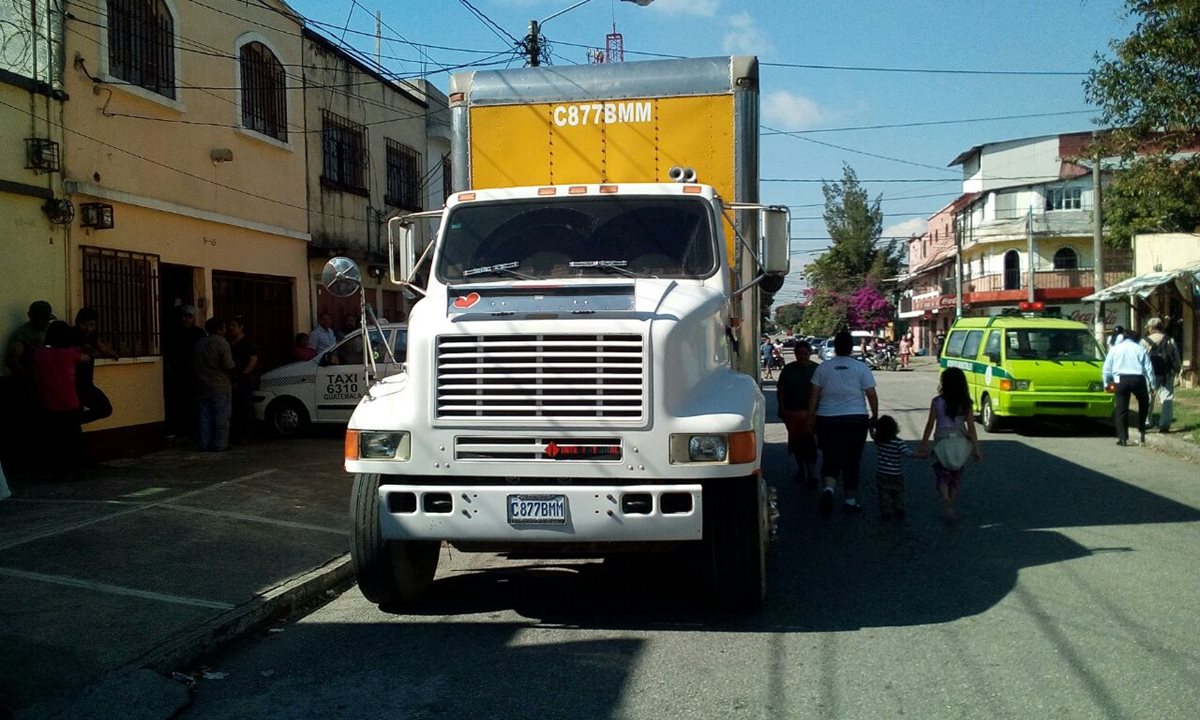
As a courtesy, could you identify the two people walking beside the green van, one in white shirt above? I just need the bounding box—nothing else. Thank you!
[1103,318,1182,446]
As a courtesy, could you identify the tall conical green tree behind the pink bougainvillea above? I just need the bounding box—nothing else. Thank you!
[803,166,901,335]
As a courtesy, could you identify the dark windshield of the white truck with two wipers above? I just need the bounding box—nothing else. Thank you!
[437,196,716,283]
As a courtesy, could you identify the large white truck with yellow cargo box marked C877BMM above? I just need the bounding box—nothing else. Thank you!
[346,58,790,607]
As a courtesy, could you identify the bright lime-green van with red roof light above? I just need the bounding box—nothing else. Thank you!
[941,314,1112,432]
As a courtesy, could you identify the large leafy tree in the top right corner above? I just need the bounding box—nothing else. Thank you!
[1084,0,1200,246]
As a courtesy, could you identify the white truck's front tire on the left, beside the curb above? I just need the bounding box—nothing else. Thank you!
[350,473,442,606]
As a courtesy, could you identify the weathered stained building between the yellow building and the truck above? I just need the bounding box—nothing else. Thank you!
[304,29,450,326]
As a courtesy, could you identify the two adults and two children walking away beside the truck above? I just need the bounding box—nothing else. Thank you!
[776,331,983,523]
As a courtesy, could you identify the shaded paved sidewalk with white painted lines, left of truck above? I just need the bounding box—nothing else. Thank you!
[0,433,353,719]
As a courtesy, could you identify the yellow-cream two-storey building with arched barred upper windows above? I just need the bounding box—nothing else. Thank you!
[60,0,312,455]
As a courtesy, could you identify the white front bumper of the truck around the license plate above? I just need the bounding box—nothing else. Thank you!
[379,484,703,542]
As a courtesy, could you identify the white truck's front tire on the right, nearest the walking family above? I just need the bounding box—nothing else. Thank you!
[704,475,767,610]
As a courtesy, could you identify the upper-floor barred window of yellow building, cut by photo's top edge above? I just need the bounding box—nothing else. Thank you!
[108,0,175,100]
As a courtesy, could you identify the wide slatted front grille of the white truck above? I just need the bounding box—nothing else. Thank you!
[437,335,646,420]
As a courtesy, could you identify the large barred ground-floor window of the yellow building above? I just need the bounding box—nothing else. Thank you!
[80,246,162,358]
